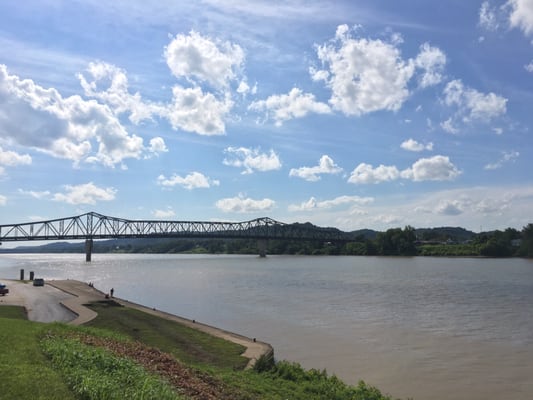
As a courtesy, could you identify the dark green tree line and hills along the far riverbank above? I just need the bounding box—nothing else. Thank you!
[94,224,533,257]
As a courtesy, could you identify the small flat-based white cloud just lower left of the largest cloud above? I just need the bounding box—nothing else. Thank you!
[249,88,331,126]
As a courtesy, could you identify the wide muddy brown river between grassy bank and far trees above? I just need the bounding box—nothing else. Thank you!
[0,254,533,400]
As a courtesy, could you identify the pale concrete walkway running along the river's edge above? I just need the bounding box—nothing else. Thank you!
[46,280,274,368]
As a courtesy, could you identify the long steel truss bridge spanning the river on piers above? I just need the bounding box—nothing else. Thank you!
[0,212,350,261]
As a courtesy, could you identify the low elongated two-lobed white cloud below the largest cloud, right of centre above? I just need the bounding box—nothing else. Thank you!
[348,155,461,184]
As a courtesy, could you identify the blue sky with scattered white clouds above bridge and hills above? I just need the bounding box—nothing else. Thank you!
[0,0,533,231]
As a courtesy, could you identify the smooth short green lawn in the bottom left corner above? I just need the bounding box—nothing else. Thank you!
[0,316,76,400]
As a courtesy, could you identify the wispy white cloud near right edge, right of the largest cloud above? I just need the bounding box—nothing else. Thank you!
[441,79,507,133]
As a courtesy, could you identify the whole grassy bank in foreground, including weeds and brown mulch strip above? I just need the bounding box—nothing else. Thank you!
[0,303,400,400]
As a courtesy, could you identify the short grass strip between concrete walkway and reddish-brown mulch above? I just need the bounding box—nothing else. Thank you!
[86,301,248,369]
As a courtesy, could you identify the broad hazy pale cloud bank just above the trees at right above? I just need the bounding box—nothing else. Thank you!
[306,185,533,231]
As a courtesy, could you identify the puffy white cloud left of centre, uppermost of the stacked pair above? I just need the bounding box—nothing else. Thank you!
[164,31,244,89]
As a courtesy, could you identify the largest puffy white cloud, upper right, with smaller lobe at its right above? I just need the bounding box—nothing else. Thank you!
[310,25,446,116]
